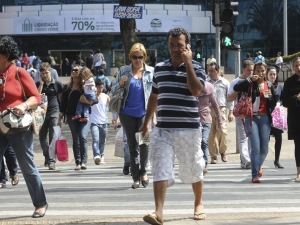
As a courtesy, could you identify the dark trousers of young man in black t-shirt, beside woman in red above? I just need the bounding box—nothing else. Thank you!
[39,113,58,164]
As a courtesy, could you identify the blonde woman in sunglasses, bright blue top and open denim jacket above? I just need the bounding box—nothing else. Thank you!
[111,43,154,189]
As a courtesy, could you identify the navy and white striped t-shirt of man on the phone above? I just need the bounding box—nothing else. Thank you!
[152,59,205,130]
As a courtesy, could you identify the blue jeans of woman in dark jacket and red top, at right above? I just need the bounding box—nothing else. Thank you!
[246,114,271,179]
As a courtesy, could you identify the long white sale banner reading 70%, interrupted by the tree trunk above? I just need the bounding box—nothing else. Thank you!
[14,15,192,34]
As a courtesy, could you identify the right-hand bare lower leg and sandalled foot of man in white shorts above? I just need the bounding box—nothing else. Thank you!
[192,180,206,220]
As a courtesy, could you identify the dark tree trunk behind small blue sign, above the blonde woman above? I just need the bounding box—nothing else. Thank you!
[120,0,138,65]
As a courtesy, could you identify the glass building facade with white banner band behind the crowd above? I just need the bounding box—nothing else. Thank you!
[0,0,300,74]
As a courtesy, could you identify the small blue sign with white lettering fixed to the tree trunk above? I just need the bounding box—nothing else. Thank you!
[113,5,143,19]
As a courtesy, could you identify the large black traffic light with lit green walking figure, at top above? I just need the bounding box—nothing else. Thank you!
[220,0,238,48]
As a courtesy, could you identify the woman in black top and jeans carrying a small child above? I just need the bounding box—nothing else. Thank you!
[57,64,98,171]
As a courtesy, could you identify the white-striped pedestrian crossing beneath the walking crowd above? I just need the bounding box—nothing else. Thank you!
[0,163,300,218]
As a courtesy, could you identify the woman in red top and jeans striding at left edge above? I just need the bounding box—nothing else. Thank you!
[0,36,48,218]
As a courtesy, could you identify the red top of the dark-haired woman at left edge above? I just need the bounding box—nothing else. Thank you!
[0,64,41,112]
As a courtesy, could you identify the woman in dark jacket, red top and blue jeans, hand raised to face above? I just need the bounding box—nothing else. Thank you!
[233,61,276,183]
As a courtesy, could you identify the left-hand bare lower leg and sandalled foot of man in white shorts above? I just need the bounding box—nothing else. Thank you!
[144,180,168,222]
